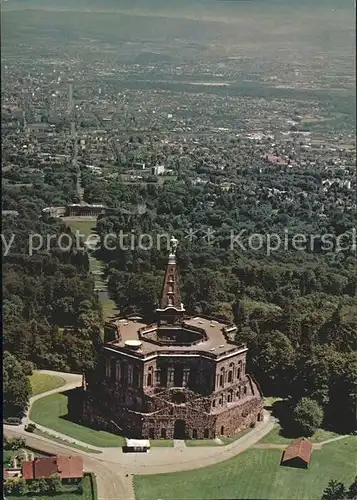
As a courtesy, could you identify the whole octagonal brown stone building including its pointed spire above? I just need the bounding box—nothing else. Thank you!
[75,238,263,439]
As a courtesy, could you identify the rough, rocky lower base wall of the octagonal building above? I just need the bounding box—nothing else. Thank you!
[83,380,263,439]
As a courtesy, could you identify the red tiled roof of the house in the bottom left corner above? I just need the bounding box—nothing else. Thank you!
[22,457,83,479]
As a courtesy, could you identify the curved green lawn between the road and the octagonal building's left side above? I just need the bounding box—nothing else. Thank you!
[30,394,124,447]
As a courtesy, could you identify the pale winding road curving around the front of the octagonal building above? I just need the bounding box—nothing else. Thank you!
[4,370,274,500]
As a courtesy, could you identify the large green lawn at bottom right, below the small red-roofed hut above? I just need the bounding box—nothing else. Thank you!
[134,436,357,500]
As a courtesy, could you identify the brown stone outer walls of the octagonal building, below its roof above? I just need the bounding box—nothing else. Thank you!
[80,332,263,439]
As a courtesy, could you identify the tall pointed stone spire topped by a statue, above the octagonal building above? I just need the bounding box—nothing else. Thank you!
[156,236,185,324]
